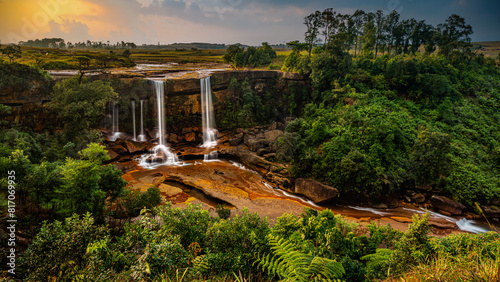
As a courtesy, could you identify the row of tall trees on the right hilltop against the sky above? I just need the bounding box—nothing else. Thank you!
[300,8,472,57]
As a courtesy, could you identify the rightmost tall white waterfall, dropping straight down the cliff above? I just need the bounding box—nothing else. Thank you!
[200,76,217,161]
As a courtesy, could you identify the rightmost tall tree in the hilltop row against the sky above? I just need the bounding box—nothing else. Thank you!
[438,14,472,56]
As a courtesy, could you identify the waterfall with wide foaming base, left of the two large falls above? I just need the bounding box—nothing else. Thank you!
[140,80,179,168]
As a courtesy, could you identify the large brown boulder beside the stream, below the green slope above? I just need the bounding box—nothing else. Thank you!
[295,178,339,203]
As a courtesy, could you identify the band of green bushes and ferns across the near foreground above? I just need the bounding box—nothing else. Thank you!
[16,204,500,281]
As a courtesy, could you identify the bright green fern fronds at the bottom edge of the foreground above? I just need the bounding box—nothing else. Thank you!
[256,235,345,281]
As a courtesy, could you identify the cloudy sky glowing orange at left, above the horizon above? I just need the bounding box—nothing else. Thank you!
[0,0,500,45]
